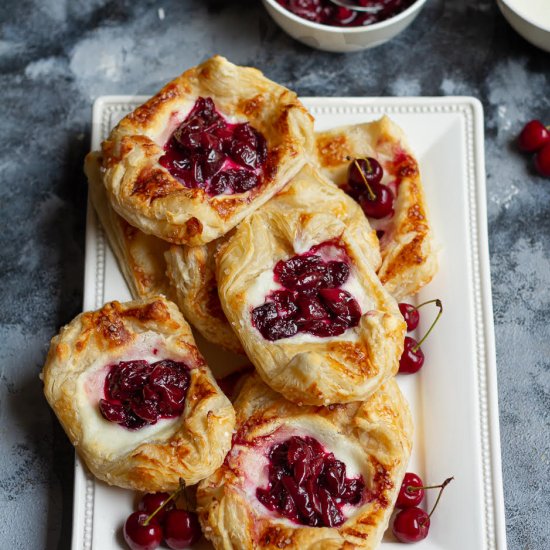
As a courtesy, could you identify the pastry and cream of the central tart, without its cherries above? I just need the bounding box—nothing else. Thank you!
[216,166,405,405]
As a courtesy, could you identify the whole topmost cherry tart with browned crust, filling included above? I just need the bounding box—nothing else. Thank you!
[102,56,314,245]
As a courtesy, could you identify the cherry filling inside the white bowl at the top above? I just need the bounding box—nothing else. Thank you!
[277,0,415,27]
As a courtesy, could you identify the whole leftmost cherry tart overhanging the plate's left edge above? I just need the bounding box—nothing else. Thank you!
[42,297,235,492]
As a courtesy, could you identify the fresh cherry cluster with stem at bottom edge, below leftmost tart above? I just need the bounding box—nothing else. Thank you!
[123,480,202,550]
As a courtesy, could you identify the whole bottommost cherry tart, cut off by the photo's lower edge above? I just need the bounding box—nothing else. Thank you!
[197,375,412,550]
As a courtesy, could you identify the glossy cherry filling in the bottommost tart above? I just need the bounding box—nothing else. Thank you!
[256,436,365,527]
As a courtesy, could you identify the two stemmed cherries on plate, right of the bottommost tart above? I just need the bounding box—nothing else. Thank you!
[392,472,453,543]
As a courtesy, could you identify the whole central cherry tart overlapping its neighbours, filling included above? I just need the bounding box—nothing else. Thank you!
[216,167,405,405]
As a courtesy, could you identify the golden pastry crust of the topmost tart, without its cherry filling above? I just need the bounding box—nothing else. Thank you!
[102,56,314,245]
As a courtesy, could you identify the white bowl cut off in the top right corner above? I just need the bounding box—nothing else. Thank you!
[497,0,550,52]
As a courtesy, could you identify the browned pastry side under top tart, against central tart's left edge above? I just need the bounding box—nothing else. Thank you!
[165,237,244,353]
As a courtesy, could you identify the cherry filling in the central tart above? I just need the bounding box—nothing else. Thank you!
[252,242,361,341]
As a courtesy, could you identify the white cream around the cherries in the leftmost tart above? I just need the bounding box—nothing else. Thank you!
[75,332,188,459]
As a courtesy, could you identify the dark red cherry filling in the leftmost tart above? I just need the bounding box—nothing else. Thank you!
[99,359,190,430]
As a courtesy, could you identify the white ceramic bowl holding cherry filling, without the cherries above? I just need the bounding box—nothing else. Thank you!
[262,0,432,52]
